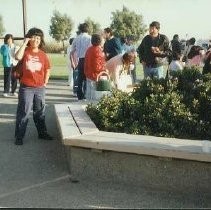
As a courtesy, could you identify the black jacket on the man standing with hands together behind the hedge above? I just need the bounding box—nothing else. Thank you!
[137,34,171,67]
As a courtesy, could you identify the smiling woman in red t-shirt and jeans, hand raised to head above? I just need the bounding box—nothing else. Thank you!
[15,28,53,145]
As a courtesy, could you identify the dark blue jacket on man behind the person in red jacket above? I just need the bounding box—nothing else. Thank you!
[104,37,122,60]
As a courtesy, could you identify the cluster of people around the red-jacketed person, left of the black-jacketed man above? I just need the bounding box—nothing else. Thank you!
[67,23,136,100]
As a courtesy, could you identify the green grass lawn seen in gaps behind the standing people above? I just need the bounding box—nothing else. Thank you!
[0,54,143,80]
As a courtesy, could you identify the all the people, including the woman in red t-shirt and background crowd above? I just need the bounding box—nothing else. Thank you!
[1,21,211,145]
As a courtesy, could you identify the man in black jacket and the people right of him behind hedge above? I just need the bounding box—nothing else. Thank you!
[138,21,211,78]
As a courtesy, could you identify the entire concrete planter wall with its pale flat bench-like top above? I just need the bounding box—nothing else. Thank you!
[55,103,211,192]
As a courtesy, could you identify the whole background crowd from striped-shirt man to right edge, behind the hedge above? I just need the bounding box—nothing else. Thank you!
[68,21,211,104]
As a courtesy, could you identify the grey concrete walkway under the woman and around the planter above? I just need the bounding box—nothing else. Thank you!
[0,80,211,209]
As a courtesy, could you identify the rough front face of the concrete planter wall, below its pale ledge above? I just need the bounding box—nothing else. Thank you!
[67,147,211,193]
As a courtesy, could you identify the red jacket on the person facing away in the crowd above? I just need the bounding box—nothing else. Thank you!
[84,46,105,81]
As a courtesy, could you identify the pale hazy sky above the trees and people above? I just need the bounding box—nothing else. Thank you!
[0,0,211,40]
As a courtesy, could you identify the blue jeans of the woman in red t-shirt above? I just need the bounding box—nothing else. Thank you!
[15,85,47,139]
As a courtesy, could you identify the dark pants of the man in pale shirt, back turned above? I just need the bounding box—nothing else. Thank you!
[77,58,86,100]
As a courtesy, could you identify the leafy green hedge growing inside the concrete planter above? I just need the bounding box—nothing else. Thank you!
[86,68,211,139]
